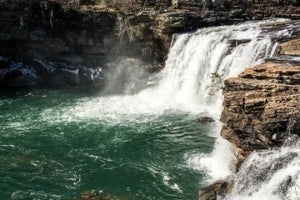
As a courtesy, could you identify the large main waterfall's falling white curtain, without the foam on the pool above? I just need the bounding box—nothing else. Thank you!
[142,23,273,114]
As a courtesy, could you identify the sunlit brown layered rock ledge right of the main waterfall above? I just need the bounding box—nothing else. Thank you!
[221,62,300,162]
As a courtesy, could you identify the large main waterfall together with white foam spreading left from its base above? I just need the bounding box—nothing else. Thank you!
[68,20,292,117]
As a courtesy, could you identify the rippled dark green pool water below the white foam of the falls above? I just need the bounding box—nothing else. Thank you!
[0,90,215,200]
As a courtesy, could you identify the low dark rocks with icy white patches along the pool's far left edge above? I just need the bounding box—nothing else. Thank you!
[0,57,103,88]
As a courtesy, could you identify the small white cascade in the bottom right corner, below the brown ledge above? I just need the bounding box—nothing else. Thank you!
[226,138,300,200]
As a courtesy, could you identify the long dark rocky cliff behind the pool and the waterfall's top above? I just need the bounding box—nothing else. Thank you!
[0,0,300,87]
